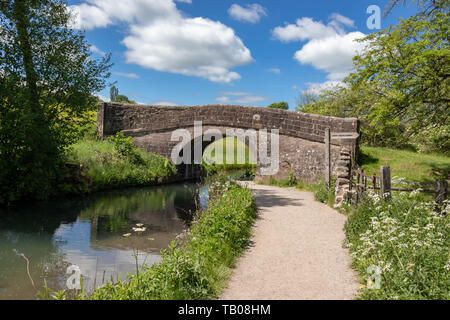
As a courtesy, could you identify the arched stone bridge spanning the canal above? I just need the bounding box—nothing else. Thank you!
[97,103,359,182]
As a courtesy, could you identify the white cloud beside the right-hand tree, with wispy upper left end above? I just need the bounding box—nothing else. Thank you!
[272,13,365,81]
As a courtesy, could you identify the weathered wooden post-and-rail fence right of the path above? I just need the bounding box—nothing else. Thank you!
[350,167,448,208]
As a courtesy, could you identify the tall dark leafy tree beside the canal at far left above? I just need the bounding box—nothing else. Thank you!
[0,0,111,203]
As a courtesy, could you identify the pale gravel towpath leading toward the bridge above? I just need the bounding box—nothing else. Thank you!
[221,183,359,300]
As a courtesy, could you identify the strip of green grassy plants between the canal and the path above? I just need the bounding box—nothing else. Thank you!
[89,181,257,300]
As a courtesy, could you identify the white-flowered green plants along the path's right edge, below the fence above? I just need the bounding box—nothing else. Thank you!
[345,192,450,300]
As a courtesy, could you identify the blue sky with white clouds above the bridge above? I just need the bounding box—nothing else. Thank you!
[68,0,415,110]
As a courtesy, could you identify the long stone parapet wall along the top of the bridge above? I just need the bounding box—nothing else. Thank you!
[98,102,359,145]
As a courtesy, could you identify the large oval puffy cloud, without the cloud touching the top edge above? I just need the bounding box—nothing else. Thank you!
[123,18,253,83]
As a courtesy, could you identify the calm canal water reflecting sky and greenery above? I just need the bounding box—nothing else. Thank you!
[0,184,207,299]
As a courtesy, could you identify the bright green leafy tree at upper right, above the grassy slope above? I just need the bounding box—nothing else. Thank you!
[347,0,450,132]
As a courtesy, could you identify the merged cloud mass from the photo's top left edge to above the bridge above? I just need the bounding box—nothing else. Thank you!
[71,0,253,83]
